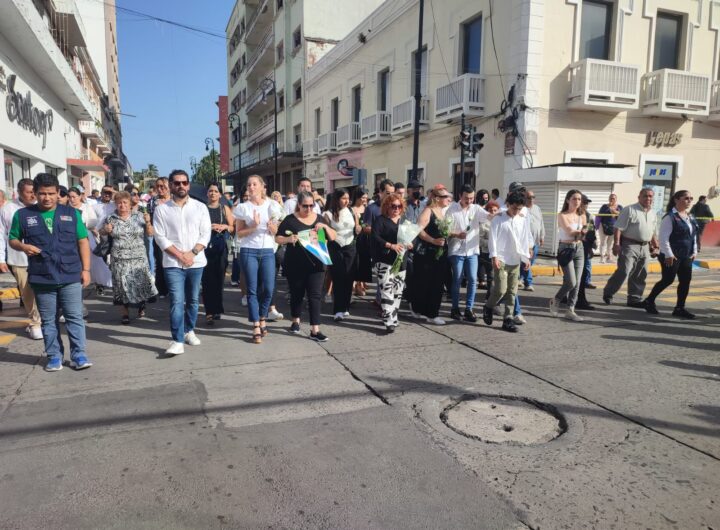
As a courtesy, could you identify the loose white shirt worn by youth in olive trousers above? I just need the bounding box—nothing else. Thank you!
[488,212,535,265]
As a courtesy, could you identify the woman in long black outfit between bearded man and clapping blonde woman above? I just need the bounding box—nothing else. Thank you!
[202,182,235,326]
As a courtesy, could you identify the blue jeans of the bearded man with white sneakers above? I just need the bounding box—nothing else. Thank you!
[164,267,203,342]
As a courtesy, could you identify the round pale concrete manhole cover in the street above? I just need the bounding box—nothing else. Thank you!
[440,394,567,445]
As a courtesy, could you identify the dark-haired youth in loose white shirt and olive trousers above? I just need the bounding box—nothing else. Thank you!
[483,191,534,332]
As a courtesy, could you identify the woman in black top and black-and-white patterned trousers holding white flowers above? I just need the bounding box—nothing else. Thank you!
[370,193,412,333]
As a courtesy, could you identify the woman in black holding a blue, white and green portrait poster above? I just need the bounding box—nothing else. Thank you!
[275,191,335,342]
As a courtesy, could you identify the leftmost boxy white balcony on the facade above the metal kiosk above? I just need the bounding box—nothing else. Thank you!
[567,59,640,111]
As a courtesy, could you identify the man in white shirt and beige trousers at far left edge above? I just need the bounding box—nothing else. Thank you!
[0,179,43,340]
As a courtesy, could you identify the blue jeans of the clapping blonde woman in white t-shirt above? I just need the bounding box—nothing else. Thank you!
[240,248,275,322]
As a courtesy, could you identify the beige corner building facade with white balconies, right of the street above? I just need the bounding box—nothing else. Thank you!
[303,0,720,233]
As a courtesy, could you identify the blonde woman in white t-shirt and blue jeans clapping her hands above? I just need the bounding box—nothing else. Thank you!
[233,175,282,344]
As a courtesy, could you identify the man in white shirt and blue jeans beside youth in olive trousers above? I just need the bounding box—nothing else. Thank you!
[445,184,488,322]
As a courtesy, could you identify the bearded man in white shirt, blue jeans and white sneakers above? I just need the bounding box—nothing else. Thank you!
[154,169,211,355]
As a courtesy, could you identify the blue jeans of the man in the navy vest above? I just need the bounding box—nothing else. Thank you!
[35,283,85,359]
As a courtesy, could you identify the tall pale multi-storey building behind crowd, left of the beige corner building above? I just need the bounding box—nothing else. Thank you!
[226,0,383,193]
